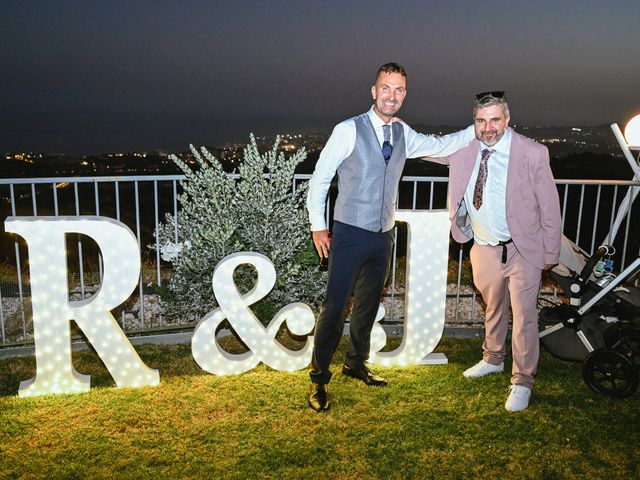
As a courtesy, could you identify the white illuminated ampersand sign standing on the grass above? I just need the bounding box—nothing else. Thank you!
[191,252,315,375]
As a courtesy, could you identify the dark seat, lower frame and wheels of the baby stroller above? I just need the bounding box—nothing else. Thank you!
[538,246,640,398]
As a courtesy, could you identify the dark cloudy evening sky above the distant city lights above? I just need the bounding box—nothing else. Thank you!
[0,0,640,153]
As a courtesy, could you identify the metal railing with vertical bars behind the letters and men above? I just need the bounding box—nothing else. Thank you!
[0,175,640,346]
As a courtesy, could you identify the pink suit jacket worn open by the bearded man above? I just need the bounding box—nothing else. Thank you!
[428,130,562,268]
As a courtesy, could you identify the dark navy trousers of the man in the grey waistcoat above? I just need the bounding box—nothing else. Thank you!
[310,221,393,383]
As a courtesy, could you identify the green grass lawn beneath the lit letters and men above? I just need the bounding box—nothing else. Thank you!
[0,339,640,479]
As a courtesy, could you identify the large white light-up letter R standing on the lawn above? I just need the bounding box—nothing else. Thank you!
[5,216,160,397]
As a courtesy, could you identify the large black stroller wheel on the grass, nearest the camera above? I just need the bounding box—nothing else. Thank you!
[582,350,638,398]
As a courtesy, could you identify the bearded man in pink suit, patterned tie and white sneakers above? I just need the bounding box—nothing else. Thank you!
[429,92,562,411]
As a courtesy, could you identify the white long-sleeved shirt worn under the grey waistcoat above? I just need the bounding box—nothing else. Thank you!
[307,107,475,231]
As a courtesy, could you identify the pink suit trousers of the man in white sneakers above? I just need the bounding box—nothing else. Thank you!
[471,242,542,389]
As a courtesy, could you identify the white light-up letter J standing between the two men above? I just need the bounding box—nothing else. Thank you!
[370,210,450,366]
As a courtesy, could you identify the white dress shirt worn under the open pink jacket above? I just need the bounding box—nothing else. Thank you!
[464,128,511,245]
